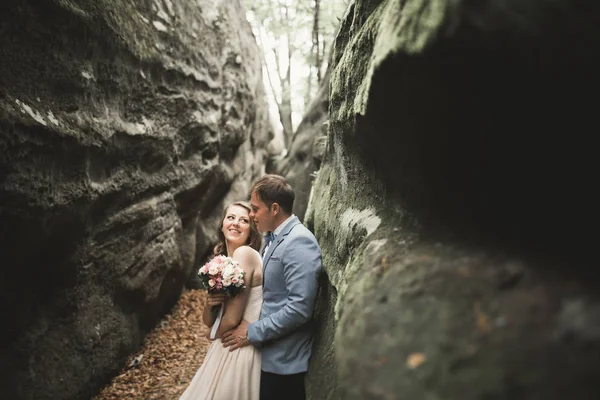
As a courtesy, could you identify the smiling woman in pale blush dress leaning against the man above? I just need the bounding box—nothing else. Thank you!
[179,202,262,400]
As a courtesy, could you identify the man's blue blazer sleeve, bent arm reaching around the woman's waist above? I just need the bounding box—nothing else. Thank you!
[248,236,322,345]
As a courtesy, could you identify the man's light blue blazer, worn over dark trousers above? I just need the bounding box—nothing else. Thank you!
[248,217,322,375]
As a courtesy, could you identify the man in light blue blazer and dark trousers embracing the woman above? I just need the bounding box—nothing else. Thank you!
[221,175,322,400]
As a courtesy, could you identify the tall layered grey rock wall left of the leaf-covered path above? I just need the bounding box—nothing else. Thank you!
[0,0,271,399]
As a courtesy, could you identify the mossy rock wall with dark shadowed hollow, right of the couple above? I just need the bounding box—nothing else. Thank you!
[308,0,600,400]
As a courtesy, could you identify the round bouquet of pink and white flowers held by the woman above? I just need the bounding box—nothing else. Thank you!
[198,255,246,297]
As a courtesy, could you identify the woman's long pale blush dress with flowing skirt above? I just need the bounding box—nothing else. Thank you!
[179,285,263,400]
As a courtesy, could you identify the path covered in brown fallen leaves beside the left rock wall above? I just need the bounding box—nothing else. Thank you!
[93,290,209,400]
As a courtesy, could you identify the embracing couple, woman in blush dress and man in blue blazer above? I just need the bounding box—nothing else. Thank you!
[180,175,322,400]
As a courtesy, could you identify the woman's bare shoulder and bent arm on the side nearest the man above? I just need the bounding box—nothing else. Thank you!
[216,246,260,338]
